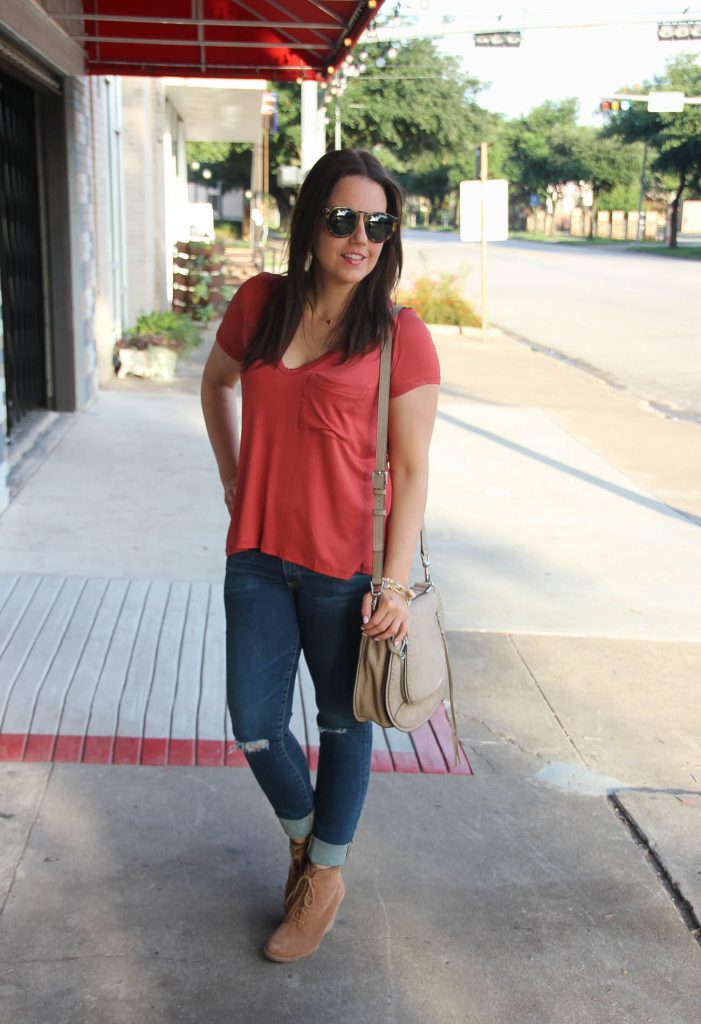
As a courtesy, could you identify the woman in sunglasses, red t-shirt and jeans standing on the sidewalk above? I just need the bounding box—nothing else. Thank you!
[202,151,440,963]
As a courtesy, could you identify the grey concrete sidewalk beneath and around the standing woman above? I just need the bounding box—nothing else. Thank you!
[0,323,701,1024]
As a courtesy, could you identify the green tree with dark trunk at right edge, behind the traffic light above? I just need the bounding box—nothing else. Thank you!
[605,53,701,247]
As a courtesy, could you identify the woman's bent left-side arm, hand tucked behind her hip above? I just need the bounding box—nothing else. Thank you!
[201,341,240,512]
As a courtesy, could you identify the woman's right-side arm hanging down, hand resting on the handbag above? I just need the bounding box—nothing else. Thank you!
[362,384,438,643]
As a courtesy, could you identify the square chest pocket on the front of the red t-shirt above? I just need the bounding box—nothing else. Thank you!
[300,374,375,452]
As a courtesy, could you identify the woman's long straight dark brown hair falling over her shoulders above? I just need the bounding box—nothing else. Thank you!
[243,150,402,370]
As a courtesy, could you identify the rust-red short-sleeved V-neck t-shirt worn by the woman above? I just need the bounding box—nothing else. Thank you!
[217,273,440,579]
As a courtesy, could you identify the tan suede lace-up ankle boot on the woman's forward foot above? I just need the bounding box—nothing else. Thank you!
[263,863,346,964]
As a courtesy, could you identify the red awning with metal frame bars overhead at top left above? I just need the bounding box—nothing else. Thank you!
[67,0,383,81]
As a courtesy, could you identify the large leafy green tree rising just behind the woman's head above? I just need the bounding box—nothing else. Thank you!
[330,39,488,221]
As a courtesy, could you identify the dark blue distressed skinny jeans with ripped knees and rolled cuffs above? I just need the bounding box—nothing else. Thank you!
[224,550,373,866]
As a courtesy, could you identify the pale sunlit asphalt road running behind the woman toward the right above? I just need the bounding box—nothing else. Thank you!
[403,230,701,425]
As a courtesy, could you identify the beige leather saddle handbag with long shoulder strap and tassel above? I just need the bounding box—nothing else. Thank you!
[353,315,461,765]
